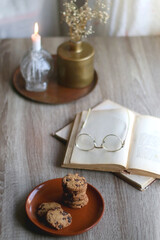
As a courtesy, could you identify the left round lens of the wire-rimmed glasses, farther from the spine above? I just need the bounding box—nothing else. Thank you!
[76,134,94,151]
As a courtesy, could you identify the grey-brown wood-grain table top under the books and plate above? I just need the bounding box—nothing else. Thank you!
[0,37,160,240]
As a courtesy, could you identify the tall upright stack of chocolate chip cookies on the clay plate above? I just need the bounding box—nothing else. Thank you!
[62,173,89,208]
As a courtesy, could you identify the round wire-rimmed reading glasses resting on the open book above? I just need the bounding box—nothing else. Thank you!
[75,109,129,152]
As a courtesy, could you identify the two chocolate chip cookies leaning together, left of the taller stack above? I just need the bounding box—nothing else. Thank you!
[37,202,72,230]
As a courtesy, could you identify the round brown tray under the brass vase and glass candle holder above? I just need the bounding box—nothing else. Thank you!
[13,55,98,104]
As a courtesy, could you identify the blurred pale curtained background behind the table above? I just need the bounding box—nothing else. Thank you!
[0,0,160,38]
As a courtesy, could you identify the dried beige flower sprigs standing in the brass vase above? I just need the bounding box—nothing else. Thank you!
[62,0,109,41]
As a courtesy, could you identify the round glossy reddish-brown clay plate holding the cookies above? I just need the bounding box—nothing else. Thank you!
[26,178,104,236]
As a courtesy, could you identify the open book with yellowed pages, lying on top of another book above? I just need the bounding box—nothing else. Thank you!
[63,101,160,178]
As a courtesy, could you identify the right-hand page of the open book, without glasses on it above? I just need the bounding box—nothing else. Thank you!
[128,116,160,174]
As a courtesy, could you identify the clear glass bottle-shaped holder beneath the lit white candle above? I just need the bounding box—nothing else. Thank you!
[20,48,53,92]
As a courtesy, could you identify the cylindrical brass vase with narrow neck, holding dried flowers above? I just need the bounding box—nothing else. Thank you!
[57,41,95,88]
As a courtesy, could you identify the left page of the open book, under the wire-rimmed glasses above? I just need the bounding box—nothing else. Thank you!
[70,108,135,167]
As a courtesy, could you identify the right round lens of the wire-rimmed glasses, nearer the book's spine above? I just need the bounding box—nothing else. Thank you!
[103,134,122,152]
